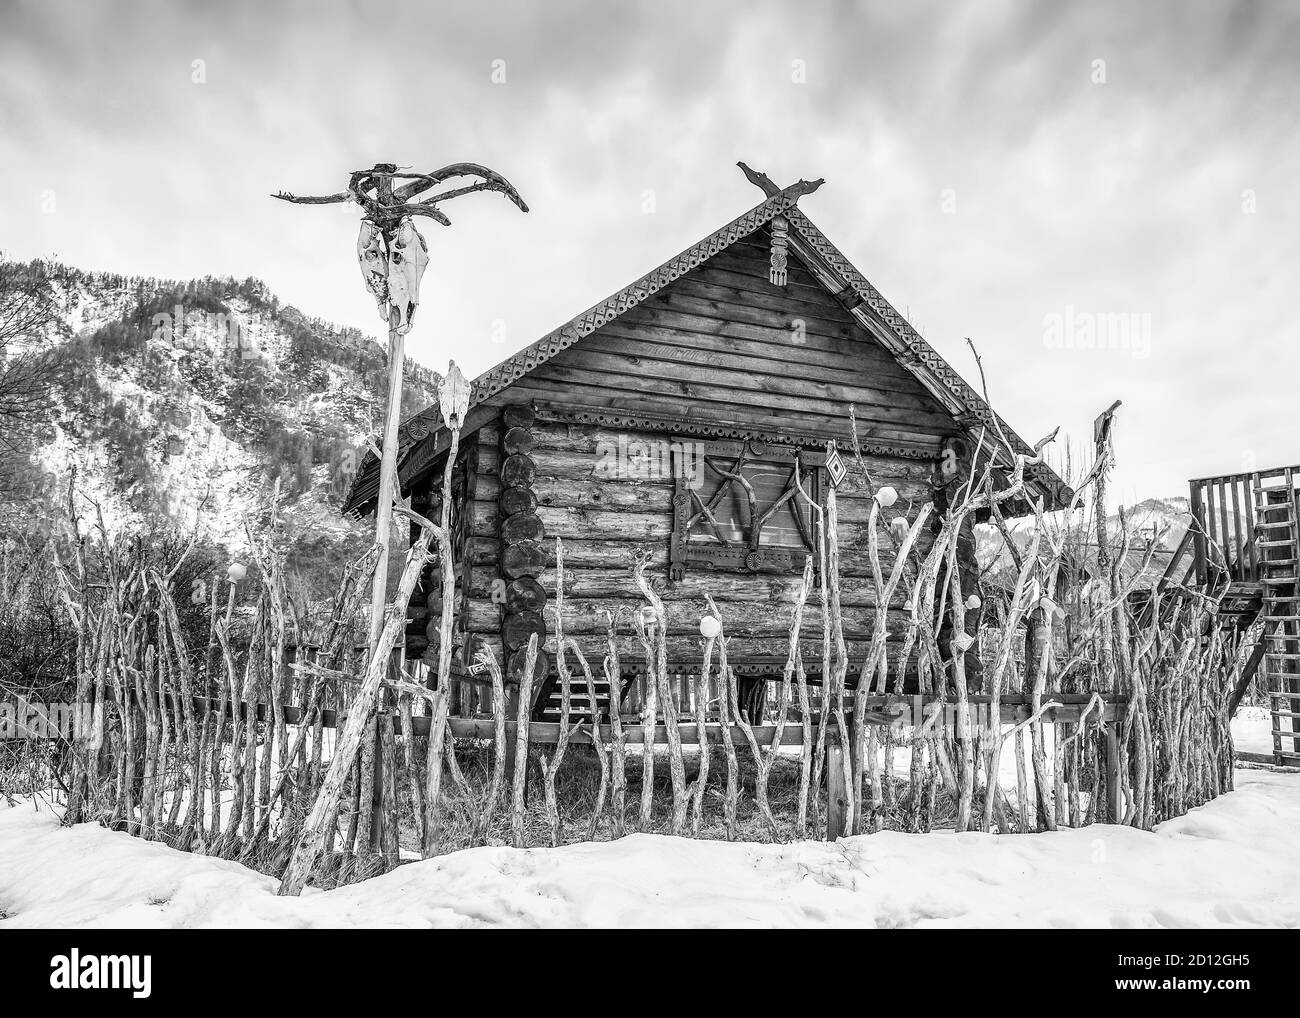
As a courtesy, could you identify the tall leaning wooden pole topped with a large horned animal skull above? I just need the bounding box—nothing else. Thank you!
[273,163,528,893]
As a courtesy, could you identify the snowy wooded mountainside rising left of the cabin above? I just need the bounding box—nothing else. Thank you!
[9,258,437,549]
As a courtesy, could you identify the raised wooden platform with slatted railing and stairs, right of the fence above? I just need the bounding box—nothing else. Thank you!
[1138,464,1300,767]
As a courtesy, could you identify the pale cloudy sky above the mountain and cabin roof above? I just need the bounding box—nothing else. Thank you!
[0,0,1300,502]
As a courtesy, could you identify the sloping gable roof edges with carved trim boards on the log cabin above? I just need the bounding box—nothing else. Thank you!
[343,181,1073,515]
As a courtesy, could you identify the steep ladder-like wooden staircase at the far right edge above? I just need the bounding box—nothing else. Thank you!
[1252,467,1300,767]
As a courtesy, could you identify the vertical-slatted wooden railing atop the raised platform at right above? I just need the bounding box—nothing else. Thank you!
[1188,465,1300,585]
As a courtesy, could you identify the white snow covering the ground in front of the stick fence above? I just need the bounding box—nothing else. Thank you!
[0,770,1300,928]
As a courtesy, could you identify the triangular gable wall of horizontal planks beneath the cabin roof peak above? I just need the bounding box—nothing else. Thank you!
[483,231,958,455]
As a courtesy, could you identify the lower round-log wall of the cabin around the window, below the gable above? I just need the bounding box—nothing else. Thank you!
[454,417,956,671]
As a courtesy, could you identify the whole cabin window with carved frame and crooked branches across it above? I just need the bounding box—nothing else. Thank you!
[670,439,826,580]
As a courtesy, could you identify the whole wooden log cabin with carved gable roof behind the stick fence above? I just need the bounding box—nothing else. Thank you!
[345,168,1071,716]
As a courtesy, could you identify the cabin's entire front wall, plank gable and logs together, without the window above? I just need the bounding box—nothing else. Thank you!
[410,230,974,681]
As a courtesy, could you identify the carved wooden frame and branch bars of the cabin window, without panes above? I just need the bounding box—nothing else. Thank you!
[668,438,828,580]
